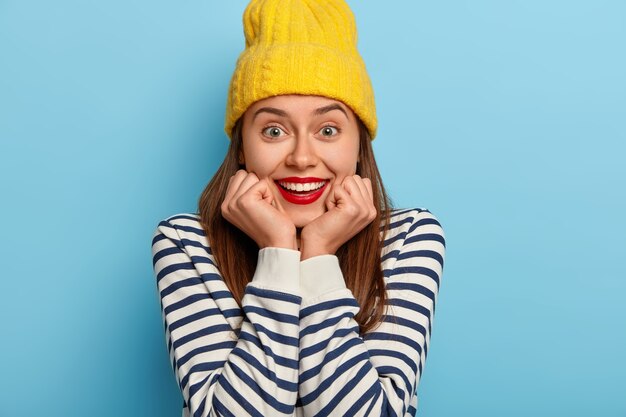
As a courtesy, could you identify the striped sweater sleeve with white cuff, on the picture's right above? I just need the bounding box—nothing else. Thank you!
[299,210,445,417]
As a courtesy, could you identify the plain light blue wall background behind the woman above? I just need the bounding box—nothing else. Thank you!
[0,0,626,417]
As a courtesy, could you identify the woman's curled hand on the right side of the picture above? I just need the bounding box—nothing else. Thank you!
[300,175,377,260]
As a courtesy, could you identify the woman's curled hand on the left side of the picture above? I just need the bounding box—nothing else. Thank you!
[221,170,297,249]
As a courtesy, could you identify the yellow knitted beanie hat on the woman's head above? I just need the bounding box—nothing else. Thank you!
[224,0,377,139]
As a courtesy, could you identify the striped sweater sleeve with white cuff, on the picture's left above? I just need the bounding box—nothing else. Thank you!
[152,221,301,416]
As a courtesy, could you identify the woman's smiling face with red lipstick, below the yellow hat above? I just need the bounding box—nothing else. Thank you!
[242,95,359,227]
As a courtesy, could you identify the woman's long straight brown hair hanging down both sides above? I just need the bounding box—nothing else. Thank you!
[198,118,391,334]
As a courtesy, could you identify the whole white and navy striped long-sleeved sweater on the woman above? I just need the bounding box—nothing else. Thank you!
[152,209,445,417]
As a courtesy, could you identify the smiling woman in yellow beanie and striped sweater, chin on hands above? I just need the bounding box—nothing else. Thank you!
[152,0,445,416]
